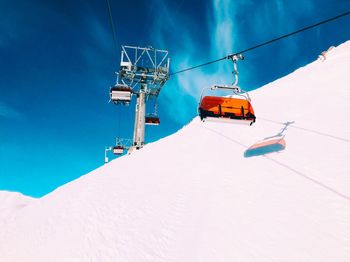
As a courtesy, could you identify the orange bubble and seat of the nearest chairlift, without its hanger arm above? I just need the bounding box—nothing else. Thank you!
[198,96,256,125]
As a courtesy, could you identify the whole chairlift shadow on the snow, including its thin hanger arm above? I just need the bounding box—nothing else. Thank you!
[244,121,294,157]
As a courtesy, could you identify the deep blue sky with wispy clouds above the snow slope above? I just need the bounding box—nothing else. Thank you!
[0,0,350,197]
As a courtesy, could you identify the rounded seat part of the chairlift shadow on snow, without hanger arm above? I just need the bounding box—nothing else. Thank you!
[244,137,286,157]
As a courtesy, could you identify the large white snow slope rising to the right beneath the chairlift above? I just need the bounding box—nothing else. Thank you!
[0,41,350,262]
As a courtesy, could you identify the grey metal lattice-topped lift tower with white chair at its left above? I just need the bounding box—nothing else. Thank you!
[110,46,170,149]
